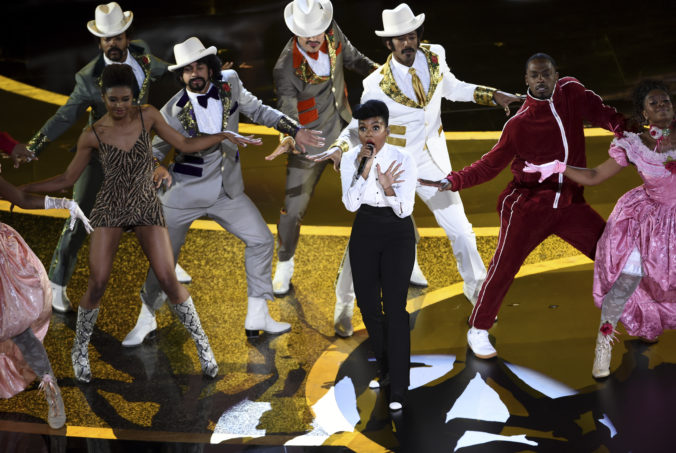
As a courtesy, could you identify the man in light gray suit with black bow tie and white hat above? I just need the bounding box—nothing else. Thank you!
[122,37,324,346]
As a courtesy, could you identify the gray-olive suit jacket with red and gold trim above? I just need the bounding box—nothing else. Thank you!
[273,22,378,154]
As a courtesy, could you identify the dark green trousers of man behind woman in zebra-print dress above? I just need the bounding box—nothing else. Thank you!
[49,156,103,286]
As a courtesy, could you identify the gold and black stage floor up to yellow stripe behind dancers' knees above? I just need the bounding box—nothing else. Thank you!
[0,212,676,452]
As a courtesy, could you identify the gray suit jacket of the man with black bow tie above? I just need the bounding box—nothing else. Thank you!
[153,70,291,208]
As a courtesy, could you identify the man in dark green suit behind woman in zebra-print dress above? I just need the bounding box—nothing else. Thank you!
[28,2,167,312]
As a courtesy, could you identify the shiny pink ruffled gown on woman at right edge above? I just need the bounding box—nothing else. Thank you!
[594,132,676,339]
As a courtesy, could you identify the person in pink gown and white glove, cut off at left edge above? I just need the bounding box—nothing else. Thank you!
[0,132,91,429]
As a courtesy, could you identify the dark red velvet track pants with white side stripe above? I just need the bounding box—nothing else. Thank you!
[469,189,605,329]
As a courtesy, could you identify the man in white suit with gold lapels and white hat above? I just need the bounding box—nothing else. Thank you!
[320,3,520,310]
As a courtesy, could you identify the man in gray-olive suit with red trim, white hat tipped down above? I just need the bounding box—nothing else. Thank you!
[273,0,378,296]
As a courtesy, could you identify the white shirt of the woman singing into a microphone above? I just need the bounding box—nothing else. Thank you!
[340,143,418,218]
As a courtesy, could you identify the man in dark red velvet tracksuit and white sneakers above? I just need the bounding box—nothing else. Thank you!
[421,53,625,359]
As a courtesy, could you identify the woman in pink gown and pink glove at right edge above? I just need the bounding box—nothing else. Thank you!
[527,80,676,378]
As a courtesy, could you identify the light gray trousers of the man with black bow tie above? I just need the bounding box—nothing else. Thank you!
[143,191,275,309]
